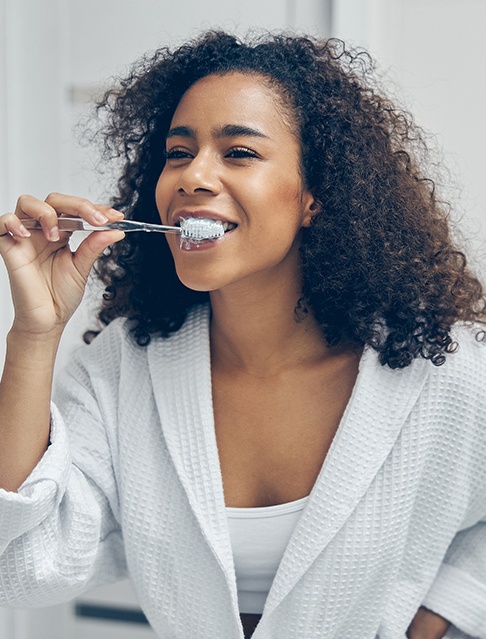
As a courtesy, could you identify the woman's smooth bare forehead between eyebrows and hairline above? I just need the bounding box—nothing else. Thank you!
[171,72,296,134]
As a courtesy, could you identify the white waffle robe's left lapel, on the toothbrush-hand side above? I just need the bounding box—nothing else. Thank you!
[148,306,237,606]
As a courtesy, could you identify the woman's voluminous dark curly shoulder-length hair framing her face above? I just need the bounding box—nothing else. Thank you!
[85,31,486,368]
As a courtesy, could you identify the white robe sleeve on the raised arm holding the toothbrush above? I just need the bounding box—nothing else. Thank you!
[0,328,126,607]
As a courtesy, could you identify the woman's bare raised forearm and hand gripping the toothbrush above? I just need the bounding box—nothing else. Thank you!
[0,194,123,491]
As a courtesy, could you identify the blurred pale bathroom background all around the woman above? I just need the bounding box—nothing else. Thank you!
[0,0,486,639]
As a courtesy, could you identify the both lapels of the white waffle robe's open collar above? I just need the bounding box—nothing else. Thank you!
[148,306,430,615]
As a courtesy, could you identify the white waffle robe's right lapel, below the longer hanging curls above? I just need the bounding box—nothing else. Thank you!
[265,349,430,614]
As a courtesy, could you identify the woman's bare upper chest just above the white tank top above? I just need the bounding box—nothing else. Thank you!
[213,359,357,507]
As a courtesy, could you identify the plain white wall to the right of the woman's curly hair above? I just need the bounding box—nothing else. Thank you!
[333,0,486,274]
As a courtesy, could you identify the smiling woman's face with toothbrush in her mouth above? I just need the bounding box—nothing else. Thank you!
[156,73,314,291]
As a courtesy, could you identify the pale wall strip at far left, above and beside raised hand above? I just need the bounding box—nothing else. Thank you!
[0,0,70,370]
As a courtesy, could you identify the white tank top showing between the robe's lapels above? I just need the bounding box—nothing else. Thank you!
[226,497,308,615]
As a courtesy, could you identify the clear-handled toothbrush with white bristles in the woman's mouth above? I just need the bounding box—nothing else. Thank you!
[22,217,224,242]
